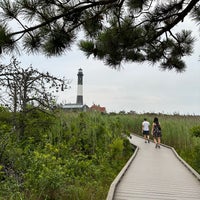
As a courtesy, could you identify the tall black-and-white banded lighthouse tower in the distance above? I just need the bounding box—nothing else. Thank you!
[76,68,83,105]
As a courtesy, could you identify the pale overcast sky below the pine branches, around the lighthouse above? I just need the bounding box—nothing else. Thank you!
[1,19,200,115]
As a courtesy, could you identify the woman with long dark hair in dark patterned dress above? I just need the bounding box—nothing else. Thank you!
[151,117,162,148]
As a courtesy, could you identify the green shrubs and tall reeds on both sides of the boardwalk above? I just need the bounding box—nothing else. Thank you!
[0,108,200,200]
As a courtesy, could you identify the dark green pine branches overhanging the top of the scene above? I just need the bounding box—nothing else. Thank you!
[0,0,200,71]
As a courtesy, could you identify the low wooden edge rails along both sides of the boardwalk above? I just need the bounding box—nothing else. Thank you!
[106,135,200,200]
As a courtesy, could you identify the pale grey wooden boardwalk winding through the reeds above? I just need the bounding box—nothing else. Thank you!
[107,135,200,200]
